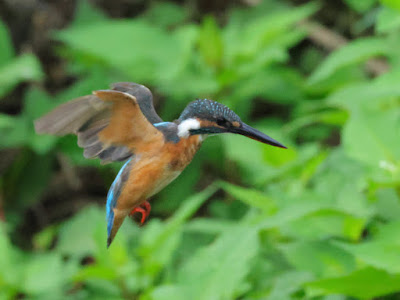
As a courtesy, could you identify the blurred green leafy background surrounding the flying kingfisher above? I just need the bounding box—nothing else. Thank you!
[0,0,400,300]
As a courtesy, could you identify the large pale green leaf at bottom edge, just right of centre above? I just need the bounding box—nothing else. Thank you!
[178,225,258,300]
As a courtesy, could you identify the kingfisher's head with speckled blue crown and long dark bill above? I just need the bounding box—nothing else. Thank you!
[178,99,286,148]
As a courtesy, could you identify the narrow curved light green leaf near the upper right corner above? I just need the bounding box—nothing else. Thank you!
[308,38,390,85]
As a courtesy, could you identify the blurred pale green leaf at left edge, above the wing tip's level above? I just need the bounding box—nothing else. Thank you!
[0,54,44,97]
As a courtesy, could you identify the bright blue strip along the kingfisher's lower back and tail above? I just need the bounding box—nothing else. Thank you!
[106,159,132,244]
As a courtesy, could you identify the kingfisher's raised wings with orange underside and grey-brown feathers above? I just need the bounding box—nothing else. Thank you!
[35,83,162,163]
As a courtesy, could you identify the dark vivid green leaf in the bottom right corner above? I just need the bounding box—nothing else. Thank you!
[306,268,400,299]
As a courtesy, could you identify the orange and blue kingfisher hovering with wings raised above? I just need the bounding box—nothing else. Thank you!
[35,82,286,247]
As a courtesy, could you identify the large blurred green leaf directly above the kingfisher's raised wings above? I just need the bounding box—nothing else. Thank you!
[56,20,181,82]
